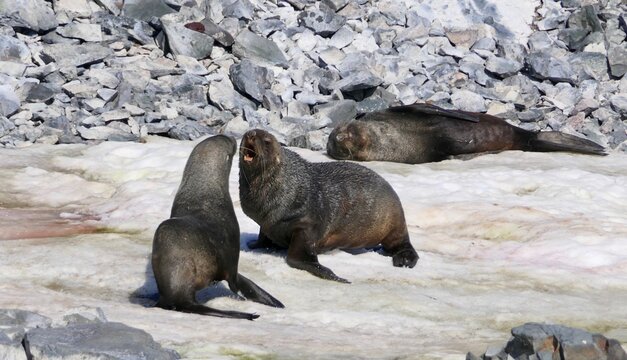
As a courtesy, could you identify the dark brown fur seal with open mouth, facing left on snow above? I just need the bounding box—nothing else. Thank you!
[239,129,418,282]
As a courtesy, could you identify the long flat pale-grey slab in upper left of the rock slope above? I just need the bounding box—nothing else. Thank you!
[42,43,113,67]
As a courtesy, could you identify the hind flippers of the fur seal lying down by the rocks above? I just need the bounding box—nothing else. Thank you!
[529,131,607,155]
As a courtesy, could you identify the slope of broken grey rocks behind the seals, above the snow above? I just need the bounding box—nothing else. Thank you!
[0,0,627,150]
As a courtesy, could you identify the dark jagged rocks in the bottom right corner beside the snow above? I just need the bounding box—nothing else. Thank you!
[466,323,627,360]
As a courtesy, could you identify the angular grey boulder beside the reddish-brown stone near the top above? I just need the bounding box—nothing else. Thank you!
[161,14,213,59]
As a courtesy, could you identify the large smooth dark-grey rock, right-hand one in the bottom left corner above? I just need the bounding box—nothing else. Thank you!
[24,322,179,360]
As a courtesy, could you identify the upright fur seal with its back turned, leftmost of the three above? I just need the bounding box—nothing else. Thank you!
[152,135,283,320]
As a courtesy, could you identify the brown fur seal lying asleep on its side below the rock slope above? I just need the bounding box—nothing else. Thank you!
[327,104,605,164]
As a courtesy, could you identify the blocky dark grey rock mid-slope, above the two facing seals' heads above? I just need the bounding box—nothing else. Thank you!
[230,59,274,102]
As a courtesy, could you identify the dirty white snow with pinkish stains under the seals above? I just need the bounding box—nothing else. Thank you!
[0,137,627,359]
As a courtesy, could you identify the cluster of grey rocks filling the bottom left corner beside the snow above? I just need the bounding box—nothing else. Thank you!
[0,308,180,360]
